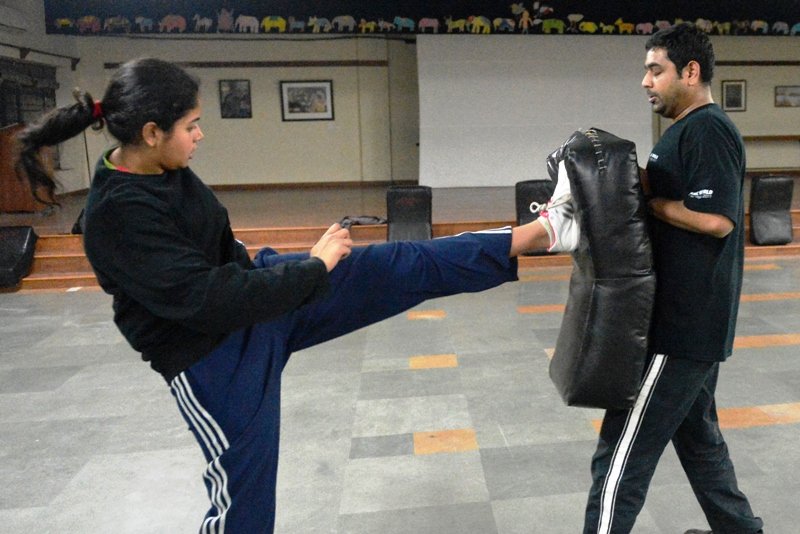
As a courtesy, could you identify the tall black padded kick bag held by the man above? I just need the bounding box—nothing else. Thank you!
[547,128,656,409]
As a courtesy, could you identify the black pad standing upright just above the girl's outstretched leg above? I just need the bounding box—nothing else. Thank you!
[386,185,433,241]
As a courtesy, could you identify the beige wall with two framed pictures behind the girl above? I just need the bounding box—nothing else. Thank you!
[0,0,418,192]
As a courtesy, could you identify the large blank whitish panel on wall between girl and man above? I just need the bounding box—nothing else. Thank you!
[417,35,652,187]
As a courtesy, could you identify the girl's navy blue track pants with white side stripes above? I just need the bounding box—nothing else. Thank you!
[171,228,517,534]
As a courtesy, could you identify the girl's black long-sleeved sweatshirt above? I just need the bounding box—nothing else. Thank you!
[84,158,329,382]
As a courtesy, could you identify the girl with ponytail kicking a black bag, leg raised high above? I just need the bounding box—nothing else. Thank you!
[18,59,578,533]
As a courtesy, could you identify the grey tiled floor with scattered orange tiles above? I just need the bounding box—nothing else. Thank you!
[0,188,800,534]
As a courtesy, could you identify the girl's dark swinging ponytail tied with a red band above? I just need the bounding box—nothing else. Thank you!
[16,89,104,206]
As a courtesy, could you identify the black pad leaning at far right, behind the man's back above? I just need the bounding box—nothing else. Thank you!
[750,176,794,245]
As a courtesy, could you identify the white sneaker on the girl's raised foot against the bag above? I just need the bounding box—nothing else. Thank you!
[531,160,581,252]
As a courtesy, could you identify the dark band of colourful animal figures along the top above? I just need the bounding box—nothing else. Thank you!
[45,0,800,35]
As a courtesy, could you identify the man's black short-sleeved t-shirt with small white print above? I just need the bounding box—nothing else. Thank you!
[647,104,745,361]
